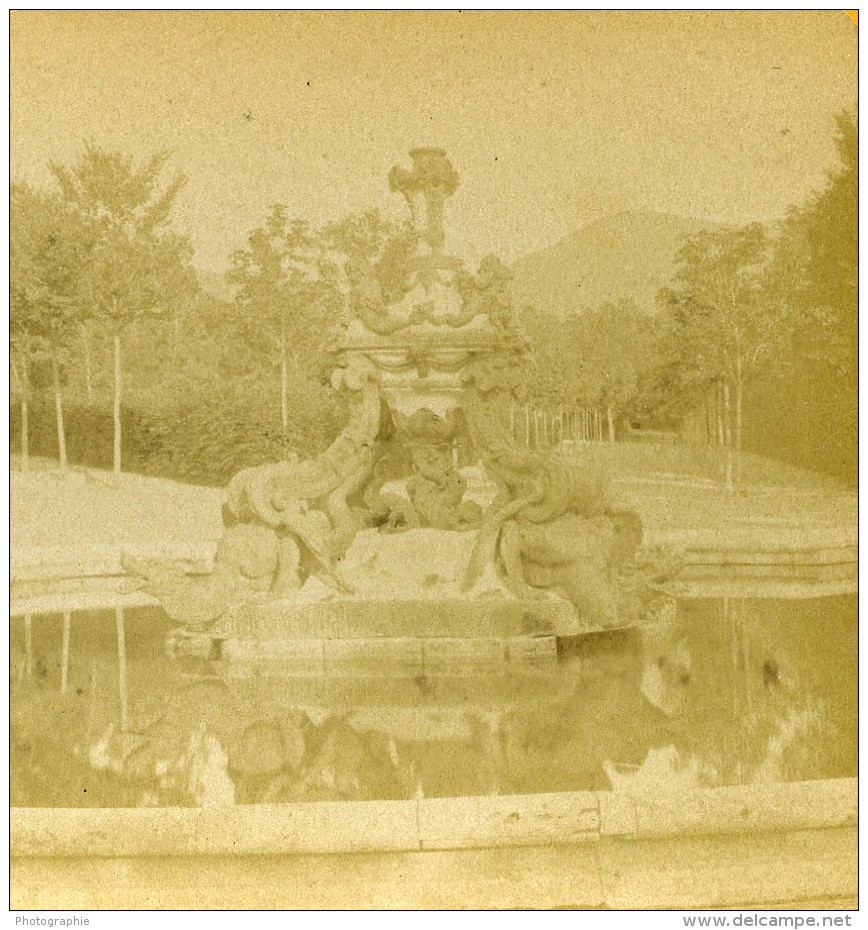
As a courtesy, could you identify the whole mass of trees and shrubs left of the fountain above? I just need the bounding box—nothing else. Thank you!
[10,143,414,480]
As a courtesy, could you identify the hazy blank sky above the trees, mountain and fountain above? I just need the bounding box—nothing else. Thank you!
[11,11,857,270]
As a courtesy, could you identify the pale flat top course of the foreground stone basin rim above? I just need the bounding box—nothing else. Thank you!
[10,778,858,858]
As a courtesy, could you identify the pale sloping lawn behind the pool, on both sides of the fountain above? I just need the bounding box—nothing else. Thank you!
[10,443,857,561]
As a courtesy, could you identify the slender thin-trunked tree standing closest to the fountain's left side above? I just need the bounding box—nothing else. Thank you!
[228,204,339,434]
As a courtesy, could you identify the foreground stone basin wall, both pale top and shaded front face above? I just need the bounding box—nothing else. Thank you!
[10,779,858,910]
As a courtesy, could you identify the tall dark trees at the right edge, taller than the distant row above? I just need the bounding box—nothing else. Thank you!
[657,113,858,477]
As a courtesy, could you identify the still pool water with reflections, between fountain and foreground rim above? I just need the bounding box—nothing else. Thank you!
[10,597,857,807]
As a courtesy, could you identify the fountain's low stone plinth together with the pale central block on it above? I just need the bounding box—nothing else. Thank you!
[169,529,584,678]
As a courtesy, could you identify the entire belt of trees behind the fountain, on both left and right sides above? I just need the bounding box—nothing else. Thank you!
[10,114,857,477]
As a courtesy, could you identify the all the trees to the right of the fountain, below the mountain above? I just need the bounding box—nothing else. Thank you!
[524,113,858,480]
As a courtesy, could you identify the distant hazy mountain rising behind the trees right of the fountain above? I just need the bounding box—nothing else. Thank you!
[512,211,715,313]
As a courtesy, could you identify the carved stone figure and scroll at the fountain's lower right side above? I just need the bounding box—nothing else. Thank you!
[465,396,678,627]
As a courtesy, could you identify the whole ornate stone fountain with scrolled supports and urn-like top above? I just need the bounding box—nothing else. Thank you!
[124,149,675,673]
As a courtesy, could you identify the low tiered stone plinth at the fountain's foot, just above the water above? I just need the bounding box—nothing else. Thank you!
[167,597,581,678]
